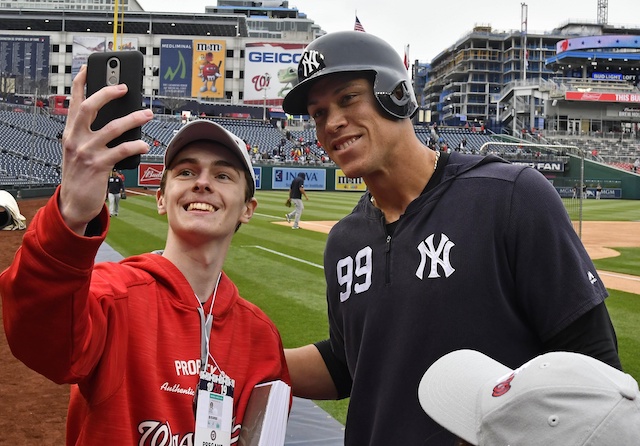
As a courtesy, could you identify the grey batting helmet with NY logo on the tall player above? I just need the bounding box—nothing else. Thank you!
[282,31,418,118]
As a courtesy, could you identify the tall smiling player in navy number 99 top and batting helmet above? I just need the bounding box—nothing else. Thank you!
[283,31,620,446]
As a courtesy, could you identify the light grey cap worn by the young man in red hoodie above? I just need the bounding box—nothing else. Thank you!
[164,119,256,196]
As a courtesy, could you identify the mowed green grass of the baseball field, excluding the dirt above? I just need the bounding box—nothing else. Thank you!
[107,191,640,423]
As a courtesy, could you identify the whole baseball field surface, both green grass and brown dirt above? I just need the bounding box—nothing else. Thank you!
[0,190,640,446]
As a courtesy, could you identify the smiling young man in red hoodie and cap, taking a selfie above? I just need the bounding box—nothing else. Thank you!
[0,68,290,446]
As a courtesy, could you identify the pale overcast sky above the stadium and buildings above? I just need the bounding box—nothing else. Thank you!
[138,0,640,62]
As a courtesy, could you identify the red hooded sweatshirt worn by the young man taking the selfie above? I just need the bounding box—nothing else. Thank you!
[0,190,290,446]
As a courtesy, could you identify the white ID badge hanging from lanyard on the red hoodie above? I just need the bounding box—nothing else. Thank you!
[194,372,235,446]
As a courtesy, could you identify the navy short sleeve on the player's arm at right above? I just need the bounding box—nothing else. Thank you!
[509,169,607,341]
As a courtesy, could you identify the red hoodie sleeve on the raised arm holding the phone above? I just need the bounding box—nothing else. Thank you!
[0,189,108,383]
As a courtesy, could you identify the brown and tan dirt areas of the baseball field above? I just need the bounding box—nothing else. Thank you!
[0,199,640,446]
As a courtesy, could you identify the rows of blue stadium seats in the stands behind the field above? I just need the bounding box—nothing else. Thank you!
[0,110,640,186]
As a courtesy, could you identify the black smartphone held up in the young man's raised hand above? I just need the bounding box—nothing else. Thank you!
[87,51,144,170]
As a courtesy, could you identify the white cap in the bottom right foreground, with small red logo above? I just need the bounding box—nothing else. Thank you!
[418,350,640,446]
